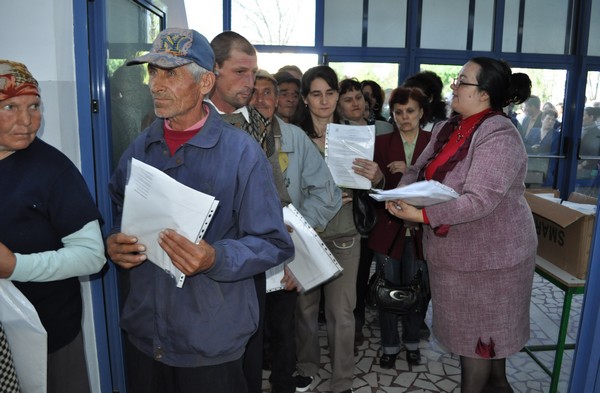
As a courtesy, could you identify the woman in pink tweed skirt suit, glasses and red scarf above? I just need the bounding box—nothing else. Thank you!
[386,57,537,393]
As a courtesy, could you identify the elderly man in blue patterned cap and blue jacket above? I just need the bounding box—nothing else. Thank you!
[107,28,293,393]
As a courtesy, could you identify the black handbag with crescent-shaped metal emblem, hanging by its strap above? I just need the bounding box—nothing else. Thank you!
[365,228,425,315]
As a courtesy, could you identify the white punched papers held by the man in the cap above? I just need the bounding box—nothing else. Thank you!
[121,158,219,288]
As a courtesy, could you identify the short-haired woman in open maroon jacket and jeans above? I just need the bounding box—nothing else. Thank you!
[355,87,431,368]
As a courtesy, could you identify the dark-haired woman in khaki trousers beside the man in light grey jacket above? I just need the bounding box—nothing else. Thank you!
[296,66,360,393]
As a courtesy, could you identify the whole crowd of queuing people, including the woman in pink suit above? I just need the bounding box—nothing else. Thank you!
[0,28,576,393]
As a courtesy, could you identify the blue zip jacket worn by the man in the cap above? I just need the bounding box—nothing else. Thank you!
[110,103,294,367]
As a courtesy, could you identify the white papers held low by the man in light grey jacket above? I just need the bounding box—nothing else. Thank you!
[267,204,343,292]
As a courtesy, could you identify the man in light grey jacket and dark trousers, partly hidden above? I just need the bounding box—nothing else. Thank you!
[250,70,342,393]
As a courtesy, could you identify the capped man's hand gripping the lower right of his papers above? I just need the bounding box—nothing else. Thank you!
[158,229,216,276]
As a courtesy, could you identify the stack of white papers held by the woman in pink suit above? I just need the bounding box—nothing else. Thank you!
[369,180,459,206]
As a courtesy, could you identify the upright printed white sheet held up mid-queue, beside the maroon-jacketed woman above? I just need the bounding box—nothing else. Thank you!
[325,123,375,190]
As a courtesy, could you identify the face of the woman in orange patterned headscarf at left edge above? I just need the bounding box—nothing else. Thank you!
[0,95,42,159]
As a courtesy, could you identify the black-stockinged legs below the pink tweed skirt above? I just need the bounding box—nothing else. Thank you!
[460,356,513,393]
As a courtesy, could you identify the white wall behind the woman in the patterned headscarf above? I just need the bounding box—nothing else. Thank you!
[0,0,100,392]
